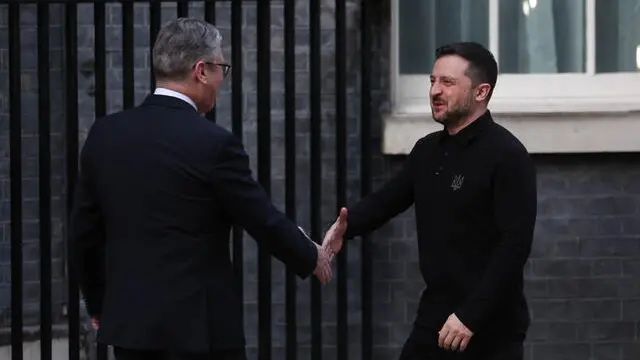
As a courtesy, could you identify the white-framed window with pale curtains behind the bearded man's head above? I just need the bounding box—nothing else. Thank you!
[392,0,640,114]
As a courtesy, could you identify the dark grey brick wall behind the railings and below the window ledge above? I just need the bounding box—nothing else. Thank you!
[0,0,640,360]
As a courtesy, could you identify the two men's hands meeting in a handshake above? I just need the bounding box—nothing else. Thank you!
[313,208,347,285]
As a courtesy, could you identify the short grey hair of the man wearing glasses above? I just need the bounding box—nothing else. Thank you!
[152,18,222,81]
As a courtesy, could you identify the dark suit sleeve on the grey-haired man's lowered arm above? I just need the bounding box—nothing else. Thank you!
[70,139,105,316]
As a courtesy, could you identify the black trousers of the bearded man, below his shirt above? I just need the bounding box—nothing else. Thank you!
[399,325,524,360]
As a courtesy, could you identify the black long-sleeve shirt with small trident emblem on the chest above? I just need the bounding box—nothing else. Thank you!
[345,111,537,335]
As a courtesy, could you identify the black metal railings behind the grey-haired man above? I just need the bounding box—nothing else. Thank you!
[6,0,373,360]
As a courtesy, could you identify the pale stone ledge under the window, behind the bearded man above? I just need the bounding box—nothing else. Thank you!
[382,112,640,155]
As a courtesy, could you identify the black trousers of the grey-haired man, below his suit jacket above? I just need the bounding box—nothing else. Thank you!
[113,347,247,360]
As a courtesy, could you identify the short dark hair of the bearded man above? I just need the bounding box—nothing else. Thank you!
[436,41,498,100]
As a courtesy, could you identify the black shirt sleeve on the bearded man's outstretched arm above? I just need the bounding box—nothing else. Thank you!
[344,140,423,239]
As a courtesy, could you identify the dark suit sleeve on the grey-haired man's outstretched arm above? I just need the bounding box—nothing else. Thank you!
[213,135,318,278]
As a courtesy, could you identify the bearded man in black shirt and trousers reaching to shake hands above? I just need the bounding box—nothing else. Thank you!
[324,42,537,360]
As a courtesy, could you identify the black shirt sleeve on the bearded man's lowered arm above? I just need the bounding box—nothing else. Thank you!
[456,147,537,332]
